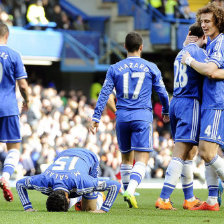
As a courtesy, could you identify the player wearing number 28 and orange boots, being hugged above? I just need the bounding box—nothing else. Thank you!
[155,24,207,210]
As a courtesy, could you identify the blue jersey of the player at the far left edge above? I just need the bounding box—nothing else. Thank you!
[0,45,27,117]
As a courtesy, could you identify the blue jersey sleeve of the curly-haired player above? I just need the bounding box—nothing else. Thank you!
[208,38,224,68]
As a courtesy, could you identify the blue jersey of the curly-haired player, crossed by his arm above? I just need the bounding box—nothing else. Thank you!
[202,33,224,109]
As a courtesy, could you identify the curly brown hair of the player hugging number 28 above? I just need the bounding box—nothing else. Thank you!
[196,3,224,33]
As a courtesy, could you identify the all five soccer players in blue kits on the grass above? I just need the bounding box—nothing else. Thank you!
[0,0,224,213]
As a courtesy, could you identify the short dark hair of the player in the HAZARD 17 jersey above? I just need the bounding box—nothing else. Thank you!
[125,32,143,53]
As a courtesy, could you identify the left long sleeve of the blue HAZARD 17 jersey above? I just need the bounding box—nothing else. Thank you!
[92,66,114,122]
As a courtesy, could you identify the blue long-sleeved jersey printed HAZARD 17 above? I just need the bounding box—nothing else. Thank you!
[93,57,169,122]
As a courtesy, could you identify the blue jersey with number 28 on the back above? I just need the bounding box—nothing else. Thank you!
[173,43,207,100]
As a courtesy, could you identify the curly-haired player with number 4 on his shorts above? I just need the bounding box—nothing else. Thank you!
[182,3,224,211]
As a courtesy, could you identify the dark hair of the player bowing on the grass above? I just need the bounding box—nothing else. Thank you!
[46,190,69,212]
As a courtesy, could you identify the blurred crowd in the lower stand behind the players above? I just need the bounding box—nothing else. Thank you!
[0,84,206,183]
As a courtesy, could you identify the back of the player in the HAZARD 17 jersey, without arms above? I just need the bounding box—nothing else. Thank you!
[113,57,158,110]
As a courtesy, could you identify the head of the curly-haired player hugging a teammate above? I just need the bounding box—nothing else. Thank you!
[197,3,224,39]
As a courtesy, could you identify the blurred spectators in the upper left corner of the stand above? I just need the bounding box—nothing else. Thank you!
[0,0,88,30]
